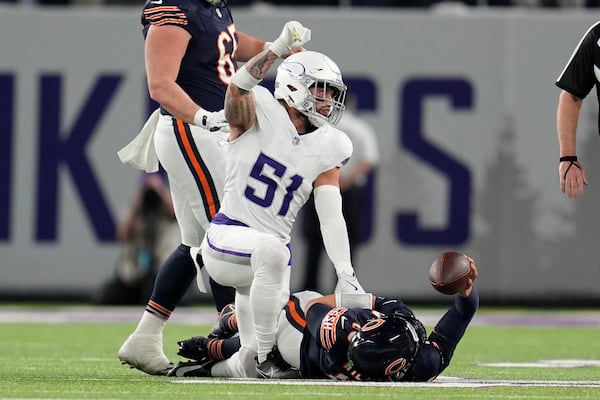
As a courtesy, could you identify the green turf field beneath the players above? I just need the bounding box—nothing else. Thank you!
[0,307,600,400]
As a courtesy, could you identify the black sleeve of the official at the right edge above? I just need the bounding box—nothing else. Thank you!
[555,22,600,131]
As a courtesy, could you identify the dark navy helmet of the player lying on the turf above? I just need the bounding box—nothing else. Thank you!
[347,314,426,381]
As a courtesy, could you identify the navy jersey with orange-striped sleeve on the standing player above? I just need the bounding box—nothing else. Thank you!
[141,0,237,111]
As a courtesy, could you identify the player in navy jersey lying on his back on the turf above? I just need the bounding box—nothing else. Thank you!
[169,261,479,382]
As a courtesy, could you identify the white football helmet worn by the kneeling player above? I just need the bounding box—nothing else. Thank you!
[275,50,347,127]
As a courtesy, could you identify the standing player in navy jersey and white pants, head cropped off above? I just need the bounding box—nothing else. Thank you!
[118,0,302,375]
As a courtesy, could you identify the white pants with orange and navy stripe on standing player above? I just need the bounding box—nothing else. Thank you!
[154,115,229,247]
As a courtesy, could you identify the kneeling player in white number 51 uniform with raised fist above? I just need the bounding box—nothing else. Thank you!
[202,21,364,378]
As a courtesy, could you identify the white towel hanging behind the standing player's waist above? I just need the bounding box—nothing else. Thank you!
[117,109,160,172]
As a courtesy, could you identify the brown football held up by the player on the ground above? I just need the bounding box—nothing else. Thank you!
[429,251,471,295]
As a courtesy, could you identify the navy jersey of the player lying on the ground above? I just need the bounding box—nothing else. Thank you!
[300,288,479,381]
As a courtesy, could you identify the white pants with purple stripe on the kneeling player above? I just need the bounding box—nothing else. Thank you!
[201,221,291,378]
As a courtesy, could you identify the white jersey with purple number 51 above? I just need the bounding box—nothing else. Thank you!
[219,86,352,243]
